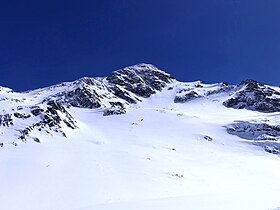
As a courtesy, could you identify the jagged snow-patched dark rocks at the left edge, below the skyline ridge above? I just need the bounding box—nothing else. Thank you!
[0,101,77,146]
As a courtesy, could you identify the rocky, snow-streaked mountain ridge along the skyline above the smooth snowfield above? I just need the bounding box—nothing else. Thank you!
[0,63,280,153]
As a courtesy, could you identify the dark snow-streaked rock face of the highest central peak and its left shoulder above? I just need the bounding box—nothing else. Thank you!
[41,64,174,109]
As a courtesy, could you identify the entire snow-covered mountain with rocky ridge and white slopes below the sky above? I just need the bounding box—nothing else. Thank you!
[0,64,280,210]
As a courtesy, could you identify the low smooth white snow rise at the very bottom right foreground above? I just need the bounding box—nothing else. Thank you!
[76,193,280,210]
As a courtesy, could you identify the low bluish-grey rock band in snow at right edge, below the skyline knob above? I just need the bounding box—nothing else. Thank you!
[227,121,280,154]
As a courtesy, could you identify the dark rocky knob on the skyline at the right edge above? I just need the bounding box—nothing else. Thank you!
[223,80,280,112]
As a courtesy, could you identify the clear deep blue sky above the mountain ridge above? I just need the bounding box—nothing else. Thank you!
[0,0,280,91]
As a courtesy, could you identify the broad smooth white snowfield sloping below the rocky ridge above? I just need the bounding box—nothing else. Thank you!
[0,80,280,210]
